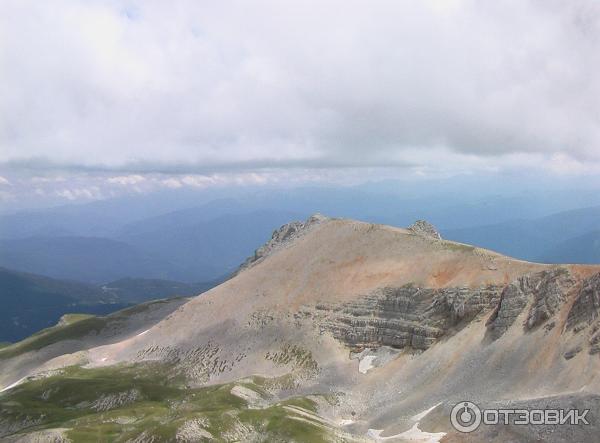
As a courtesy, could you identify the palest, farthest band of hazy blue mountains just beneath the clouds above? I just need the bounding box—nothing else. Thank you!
[0,176,600,239]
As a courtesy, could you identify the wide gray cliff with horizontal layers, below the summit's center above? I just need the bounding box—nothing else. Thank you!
[317,286,501,351]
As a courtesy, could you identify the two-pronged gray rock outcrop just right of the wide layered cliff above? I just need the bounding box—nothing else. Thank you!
[487,268,575,340]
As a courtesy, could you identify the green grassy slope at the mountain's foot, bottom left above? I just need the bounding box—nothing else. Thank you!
[0,363,329,442]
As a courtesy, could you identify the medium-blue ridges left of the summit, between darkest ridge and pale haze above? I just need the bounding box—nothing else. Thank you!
[0,207,298,283]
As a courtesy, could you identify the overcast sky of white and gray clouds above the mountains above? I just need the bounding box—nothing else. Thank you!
[0,0,600,205]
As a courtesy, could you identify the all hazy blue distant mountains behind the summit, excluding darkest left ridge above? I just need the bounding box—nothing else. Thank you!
[0,190,600,284]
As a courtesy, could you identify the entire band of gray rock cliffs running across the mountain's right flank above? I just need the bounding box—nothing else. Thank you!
[316,267,600,355]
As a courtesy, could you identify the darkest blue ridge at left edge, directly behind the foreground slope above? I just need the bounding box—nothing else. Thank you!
[0,268,219,342]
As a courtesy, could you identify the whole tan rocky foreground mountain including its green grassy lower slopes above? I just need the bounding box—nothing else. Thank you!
[0,215,600,442]
